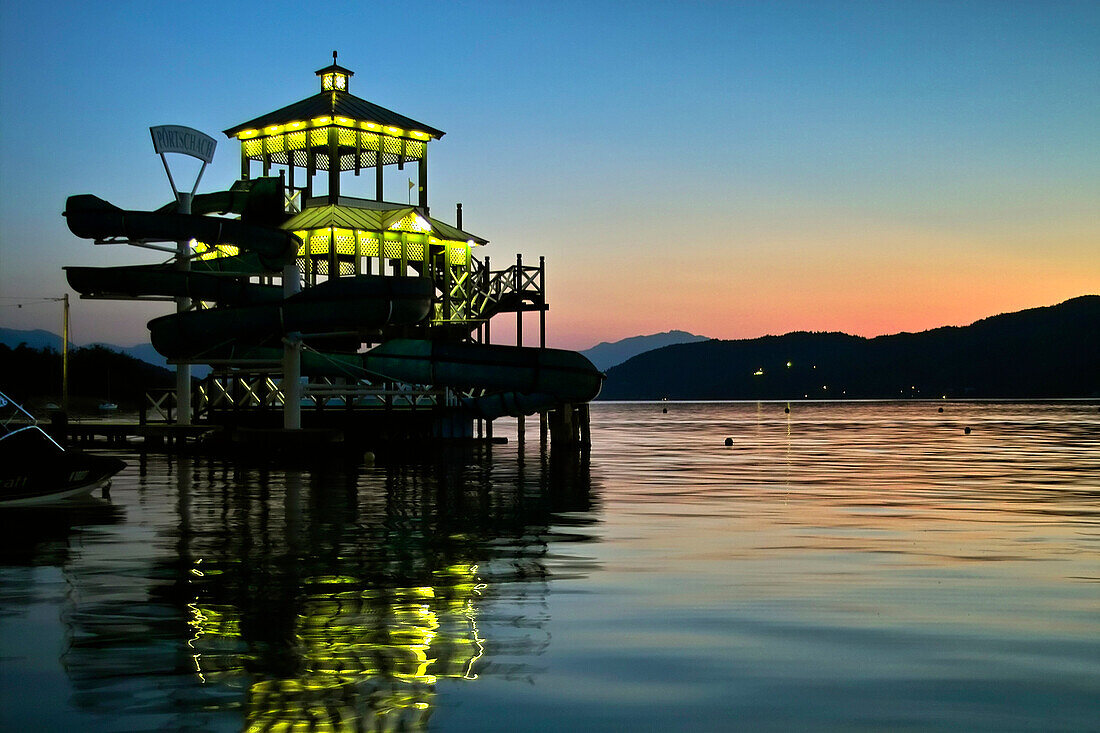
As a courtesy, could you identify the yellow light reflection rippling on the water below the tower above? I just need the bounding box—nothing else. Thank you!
[188,564,487,731]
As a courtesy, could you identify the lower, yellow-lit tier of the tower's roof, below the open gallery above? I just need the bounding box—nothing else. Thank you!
[282,197,488,244]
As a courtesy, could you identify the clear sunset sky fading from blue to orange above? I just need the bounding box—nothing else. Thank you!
[0,0,1100,349]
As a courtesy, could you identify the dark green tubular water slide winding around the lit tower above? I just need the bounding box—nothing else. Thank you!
[65,179,604,418]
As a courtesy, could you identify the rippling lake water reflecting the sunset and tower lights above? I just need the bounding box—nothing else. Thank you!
[0,402,1100,731]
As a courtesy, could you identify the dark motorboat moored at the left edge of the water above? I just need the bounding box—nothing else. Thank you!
[0,392,125,507]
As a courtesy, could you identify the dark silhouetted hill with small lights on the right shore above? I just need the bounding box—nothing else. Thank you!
[600,295,1100,400]
